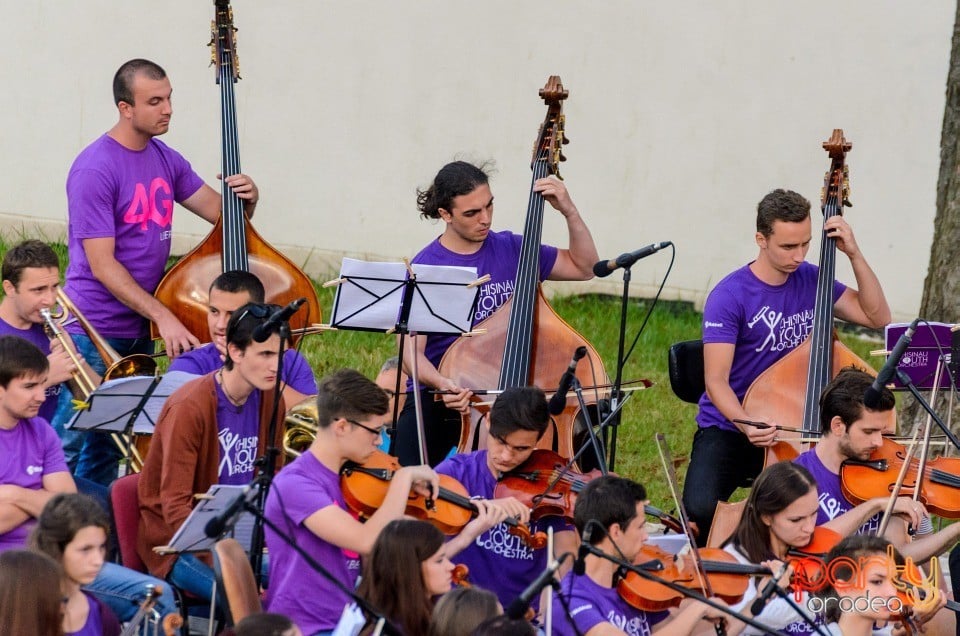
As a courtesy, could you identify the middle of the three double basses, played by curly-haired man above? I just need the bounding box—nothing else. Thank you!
[438,75,607,468]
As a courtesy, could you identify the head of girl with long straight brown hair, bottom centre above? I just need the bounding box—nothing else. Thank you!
[357,519,453,636]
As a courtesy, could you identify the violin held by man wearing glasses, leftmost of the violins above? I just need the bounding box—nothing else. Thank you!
[340,451,547,550]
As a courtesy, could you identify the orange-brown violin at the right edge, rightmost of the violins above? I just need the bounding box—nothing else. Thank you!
[840,437,960,519]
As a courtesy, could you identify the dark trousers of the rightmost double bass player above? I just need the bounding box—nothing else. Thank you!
[683,426,764,546]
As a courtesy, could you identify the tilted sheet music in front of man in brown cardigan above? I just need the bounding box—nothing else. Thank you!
[154,484,260,554]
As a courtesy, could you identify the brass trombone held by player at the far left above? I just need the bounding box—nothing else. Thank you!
[40,289,157,472]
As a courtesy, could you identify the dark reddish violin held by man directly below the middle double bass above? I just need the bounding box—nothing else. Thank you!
[493,448,600,520]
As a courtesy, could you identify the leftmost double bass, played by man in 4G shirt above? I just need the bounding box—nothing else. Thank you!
[151,0,321,342]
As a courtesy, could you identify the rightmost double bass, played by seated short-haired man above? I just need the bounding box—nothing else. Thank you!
[743,128,876,464]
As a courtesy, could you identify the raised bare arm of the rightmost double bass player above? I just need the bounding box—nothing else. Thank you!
[823,216,891,329]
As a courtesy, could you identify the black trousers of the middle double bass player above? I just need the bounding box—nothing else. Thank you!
[391,391,460,466]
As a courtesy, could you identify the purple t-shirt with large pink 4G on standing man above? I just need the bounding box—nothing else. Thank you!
[64,134,203,338]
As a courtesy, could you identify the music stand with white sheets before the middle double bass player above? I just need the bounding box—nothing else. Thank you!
[327,258,489,463]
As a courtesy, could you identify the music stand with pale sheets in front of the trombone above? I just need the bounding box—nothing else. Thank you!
[66,371,200,466]
